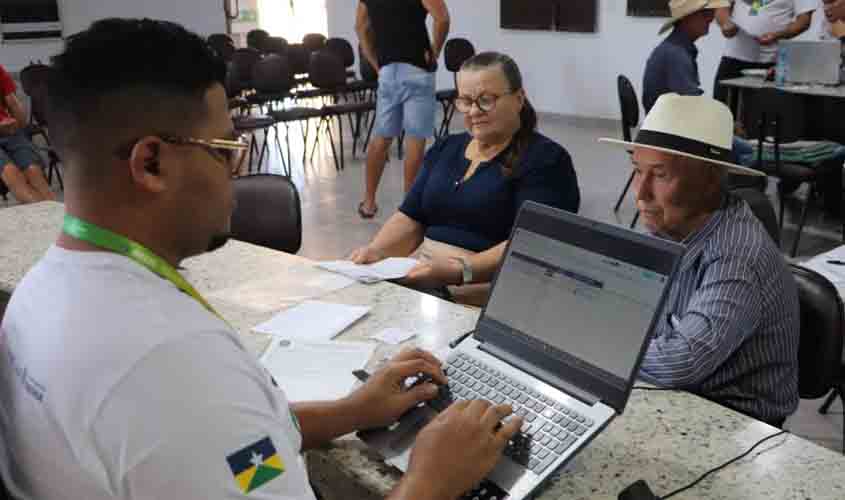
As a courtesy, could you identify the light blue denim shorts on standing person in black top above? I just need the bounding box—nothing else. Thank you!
[373,63,437,139]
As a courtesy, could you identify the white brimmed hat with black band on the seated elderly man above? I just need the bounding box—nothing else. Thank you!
[599,94,765,176]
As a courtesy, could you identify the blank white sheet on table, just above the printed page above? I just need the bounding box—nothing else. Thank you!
[253,300,370,342]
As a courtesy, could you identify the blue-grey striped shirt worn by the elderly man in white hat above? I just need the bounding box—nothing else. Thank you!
[640,195,800,422]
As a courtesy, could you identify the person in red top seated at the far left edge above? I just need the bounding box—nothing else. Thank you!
[0,65,56,203]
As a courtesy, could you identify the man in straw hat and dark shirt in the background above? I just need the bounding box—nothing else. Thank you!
[643,0,731,113]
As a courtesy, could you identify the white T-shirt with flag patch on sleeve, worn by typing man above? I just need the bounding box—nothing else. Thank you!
[0,247,313,500]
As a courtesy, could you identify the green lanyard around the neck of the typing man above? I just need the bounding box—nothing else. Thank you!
[62,215,226,322]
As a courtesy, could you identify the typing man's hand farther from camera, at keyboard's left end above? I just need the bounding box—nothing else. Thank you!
[342,349,447,429]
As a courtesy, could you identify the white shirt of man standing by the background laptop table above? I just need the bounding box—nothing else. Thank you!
[725,0,821,63]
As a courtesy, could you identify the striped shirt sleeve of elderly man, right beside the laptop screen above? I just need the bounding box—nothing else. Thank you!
[640,257,763,388]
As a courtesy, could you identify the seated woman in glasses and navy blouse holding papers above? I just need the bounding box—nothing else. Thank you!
[350,52,580,305]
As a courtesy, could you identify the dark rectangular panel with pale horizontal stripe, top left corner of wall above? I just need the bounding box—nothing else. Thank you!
[0,0,62,42]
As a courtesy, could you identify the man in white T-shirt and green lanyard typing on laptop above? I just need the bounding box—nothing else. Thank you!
[0,19,521,500]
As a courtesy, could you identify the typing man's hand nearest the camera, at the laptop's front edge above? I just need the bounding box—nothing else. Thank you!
[406,401,522,498]
